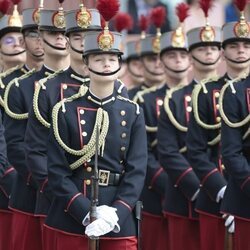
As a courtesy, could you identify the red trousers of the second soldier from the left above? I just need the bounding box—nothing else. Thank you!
[12,211,42,250]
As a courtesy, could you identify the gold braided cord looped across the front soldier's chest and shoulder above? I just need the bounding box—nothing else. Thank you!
[52,90,109,170]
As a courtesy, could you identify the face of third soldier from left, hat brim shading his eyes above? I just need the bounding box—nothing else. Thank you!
[41,31,69,56]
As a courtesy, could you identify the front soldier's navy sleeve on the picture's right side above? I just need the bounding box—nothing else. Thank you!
[113,110,147,225]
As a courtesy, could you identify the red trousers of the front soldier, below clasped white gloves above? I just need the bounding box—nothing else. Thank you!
[43,225,137,250]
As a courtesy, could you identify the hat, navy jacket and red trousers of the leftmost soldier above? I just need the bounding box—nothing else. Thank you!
[0,3,27,250]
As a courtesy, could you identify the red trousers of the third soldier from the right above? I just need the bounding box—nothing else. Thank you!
[167,215,200,250]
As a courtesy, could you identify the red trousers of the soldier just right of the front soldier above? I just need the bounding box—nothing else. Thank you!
[141,212,169,250]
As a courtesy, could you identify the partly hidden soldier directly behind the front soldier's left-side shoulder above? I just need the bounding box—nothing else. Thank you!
[25,2,101,236]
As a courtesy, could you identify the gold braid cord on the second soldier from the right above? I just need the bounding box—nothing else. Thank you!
[192,77,221,130]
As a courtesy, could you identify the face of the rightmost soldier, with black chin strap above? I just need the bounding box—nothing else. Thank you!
[223,42,250,70]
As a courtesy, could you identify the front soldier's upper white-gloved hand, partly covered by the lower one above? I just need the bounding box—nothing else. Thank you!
[82,205,118,226]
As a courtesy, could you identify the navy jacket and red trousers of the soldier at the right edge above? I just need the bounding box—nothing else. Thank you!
[221,77,250,249]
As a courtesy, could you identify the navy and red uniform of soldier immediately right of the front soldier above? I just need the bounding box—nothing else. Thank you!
[134,30,168,250]
